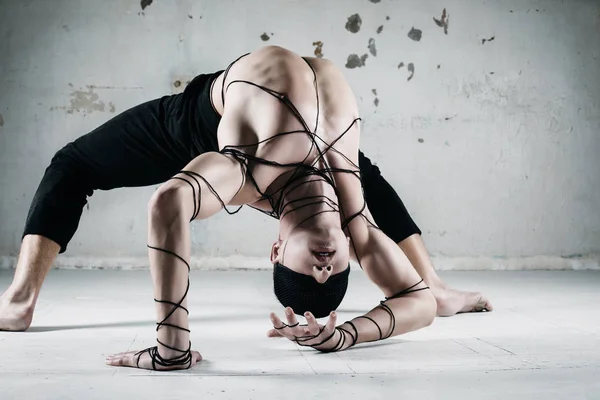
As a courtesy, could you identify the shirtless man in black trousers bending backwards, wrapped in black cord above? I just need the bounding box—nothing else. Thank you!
[0,47,491,369]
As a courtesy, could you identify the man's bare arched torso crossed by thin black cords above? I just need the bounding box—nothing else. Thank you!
[211,46,360,209]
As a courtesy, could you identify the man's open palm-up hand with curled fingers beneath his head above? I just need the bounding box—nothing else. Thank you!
[267,307,352,352]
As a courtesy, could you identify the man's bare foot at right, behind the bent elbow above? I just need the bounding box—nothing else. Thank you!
[431,287,494,317]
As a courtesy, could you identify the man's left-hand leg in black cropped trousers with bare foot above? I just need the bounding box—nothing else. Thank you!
[0,96,196,331]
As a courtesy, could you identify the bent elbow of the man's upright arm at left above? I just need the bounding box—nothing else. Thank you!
[148,181,189,225]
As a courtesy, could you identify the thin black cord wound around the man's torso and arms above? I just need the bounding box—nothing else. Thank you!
[144,54,426,358]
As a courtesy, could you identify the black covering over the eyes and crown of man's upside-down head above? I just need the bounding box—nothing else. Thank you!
[273,263,350,318]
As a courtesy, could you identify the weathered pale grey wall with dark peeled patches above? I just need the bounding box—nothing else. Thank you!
[0,0,600,265]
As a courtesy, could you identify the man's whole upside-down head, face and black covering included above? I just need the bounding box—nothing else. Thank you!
[271,227,350,318]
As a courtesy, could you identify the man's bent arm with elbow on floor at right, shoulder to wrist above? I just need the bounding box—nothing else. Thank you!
[334,148,436,350]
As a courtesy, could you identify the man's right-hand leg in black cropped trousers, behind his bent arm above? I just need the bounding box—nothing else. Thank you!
[358,152,493,316]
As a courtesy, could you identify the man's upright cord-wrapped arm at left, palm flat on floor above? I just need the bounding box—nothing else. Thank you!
[107,152,245,370]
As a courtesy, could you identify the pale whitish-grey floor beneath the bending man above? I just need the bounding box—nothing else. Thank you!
[0,270,600,400]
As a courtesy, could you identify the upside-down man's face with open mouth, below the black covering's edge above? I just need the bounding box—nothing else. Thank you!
[271,228,350,283]
